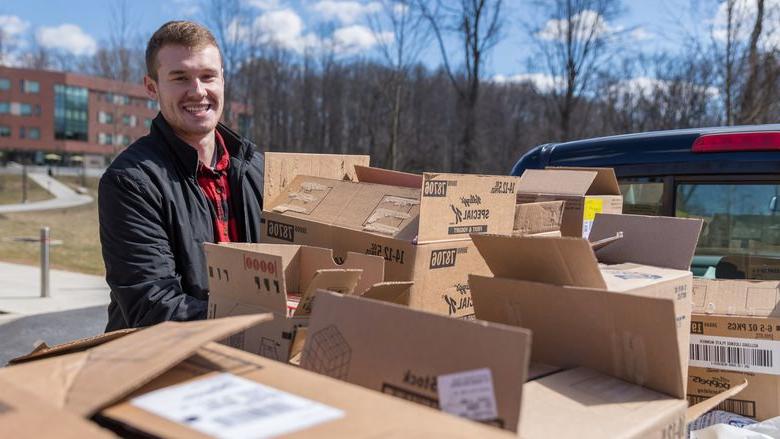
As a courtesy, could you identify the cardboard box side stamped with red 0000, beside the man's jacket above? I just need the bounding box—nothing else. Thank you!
[203,243,292,315]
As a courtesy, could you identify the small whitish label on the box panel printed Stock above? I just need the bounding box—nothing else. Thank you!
[436,368,498,421]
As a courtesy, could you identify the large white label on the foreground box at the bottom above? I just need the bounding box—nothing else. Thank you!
[130,373,344,438]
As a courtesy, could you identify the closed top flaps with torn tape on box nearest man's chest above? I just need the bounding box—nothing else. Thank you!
[265,176,420,241]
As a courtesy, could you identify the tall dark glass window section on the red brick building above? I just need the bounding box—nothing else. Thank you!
[54,84,89,142]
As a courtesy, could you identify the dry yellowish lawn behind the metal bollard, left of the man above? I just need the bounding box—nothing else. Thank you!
[0,176,105,275]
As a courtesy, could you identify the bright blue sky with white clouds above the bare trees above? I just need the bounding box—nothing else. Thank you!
[0,0,736,77]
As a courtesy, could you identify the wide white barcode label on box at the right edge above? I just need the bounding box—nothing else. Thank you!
[689,334,780,375]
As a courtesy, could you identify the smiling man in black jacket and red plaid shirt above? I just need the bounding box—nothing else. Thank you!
[98,21,263,331]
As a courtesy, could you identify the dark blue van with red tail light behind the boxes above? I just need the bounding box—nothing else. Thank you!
[512,124,780,279]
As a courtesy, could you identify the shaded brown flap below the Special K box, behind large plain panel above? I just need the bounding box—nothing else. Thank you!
[471,235,607,289]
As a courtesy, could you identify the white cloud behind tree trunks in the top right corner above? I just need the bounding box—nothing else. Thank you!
[712,0,780,50]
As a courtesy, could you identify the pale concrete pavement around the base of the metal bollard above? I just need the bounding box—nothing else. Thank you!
[0,262,109,316]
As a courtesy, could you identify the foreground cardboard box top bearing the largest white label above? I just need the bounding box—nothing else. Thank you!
[100,343,511,438]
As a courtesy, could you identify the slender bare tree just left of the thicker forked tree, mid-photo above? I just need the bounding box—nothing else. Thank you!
[368,0,429,169]
